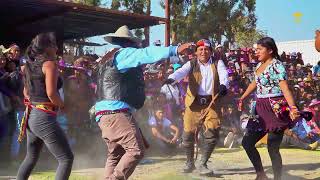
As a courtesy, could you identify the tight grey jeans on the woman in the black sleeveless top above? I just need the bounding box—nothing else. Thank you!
[17,109,73,180]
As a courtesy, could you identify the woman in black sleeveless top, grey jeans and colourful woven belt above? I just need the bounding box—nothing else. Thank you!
[17,33,73,180]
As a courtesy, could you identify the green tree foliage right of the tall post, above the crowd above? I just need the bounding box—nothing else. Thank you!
[161,0,256,46]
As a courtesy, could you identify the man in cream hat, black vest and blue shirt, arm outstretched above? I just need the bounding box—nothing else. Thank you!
[95,26,191,180]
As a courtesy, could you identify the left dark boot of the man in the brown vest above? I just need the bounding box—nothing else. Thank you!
[182,132,196,173]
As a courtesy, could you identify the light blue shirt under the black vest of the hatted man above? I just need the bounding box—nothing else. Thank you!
[95,46,178,122]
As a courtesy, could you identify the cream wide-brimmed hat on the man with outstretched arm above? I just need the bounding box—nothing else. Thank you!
[104,25,140,44]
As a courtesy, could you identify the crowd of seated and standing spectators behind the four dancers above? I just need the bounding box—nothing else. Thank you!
[0,40,320,165]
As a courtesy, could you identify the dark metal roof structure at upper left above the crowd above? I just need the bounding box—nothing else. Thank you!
[0,0,165,47]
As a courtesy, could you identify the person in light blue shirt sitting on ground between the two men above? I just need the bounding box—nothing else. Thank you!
[148,108,180,150]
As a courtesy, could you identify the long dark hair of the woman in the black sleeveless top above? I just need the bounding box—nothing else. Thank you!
[24,32,57,89]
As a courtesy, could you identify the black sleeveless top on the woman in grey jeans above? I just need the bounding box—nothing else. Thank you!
[26,61,62,102]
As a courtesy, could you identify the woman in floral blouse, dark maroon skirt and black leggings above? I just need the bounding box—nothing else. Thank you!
[239,37,300,180]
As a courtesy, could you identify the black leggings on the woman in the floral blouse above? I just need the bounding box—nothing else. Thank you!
[242,131,283,179]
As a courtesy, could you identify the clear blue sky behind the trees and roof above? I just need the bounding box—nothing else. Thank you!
[90,0,320,54]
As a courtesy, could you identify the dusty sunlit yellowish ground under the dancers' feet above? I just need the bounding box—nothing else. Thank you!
[0,148,320,180]
